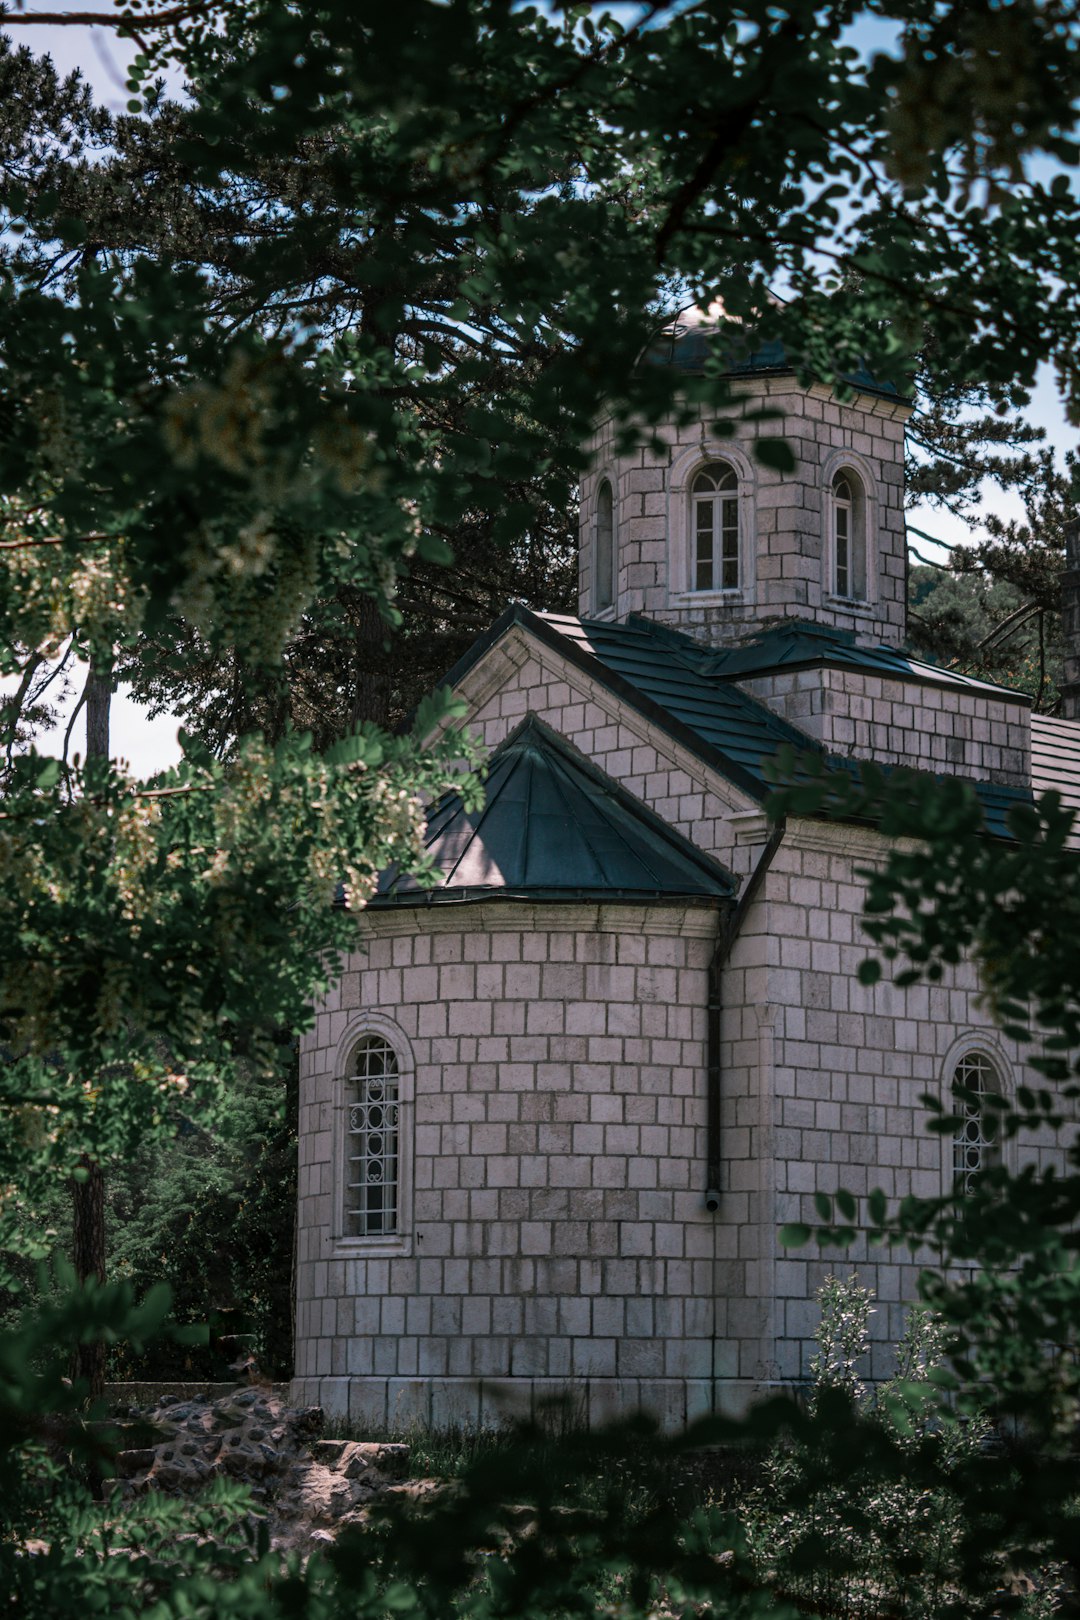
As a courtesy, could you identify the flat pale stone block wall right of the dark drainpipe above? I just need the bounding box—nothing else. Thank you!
[735,821,1064,1383]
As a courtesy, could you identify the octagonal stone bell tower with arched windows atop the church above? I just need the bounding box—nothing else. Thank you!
[578,309,912,646]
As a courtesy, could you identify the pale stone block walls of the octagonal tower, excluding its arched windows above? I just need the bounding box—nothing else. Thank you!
[578,377,910,645]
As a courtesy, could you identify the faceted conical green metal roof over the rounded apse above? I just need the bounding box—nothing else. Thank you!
[372,716,735,906]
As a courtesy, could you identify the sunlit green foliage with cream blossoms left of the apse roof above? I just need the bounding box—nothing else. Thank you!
[0,710,476,1276]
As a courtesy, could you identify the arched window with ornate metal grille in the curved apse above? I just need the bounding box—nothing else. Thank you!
[345,1035,400,1238]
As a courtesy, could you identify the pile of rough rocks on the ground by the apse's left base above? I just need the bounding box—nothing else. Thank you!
[112,1387,410,1549]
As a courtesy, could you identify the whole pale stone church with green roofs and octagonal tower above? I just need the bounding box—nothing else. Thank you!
[286,321,1080,1427]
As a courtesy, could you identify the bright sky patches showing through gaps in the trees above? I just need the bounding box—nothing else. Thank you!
[3,0,1080,776]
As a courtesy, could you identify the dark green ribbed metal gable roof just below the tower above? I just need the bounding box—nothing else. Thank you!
[445,603,1031,838]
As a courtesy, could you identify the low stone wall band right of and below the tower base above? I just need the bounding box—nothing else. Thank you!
[740,669,1031,787]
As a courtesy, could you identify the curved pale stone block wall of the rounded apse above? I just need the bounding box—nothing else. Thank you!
[296,901,731,1426]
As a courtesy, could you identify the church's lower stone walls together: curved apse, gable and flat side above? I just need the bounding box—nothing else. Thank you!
[295,642,1056,1426]
